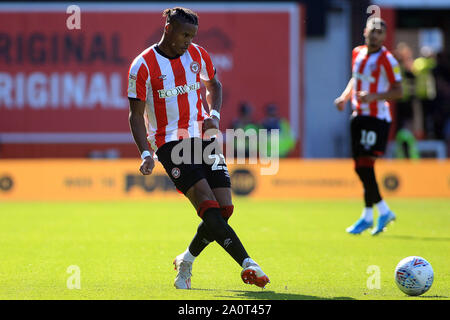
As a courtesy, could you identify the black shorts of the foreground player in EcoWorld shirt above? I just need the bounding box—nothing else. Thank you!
[156,138,231,194]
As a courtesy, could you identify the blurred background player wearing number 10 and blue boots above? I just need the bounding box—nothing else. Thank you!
[334,18,402,235]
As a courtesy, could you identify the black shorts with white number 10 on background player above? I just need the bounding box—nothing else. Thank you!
[350,116,391,159]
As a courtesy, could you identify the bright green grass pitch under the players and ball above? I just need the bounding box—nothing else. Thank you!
[0,197,450,300]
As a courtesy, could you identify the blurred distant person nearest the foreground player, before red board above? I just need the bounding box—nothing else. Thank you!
[231,102,259,158]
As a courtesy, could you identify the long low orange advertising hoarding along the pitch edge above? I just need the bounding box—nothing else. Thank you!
[0,159,450,201]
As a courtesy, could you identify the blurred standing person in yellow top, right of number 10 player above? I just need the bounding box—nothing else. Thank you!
[413,47,436,139]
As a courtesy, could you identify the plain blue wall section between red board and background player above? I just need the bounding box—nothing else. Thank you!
[303,1,351,159]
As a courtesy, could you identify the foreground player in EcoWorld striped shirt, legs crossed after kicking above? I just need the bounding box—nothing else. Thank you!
[128,7,269,289]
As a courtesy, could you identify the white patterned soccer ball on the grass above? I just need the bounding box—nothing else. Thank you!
[395,256,434,296]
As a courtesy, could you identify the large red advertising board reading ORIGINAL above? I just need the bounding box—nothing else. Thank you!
[0,3,302,158]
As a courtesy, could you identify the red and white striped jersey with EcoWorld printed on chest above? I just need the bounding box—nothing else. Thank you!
[128,44,215,151]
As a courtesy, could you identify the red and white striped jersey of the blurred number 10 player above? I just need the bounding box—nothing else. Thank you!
[352,45,402,122]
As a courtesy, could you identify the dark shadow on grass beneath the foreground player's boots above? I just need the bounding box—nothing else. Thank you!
[191,288,355,300]
